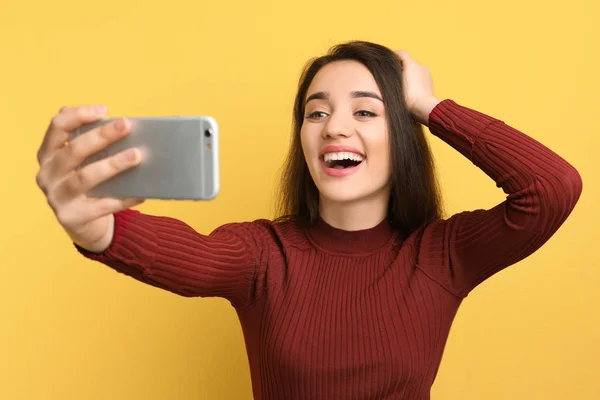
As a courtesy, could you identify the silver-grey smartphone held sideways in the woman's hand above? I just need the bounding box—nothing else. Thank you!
[70,116,219,200]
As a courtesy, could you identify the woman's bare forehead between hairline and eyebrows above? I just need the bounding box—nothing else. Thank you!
[307,60,381,96]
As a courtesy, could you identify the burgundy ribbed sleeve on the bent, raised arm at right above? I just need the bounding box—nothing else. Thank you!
[417,100,582,298]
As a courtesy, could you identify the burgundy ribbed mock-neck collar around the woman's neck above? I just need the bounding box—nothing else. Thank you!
[308,216,393,255]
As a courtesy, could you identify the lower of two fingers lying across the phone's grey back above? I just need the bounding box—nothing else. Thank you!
[53,148,141,204]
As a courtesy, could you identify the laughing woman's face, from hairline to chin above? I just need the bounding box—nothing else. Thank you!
[300,60,391,205]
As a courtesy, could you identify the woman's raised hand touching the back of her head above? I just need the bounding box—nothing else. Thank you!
[396,50,440,126]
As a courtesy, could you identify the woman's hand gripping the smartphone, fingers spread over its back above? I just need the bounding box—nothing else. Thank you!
[36,106,143,252]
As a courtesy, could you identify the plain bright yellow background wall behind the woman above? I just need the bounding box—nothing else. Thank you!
[0,0,600,400]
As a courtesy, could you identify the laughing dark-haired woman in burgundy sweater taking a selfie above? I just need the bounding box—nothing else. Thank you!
[37,42,582,400]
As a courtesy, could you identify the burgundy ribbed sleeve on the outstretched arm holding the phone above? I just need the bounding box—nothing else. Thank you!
[75,210,267,307]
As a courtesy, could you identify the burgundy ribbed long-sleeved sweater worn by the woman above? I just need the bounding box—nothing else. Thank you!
[78,100,582,400]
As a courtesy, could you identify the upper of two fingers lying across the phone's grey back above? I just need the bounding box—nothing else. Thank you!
[47,119,131,180]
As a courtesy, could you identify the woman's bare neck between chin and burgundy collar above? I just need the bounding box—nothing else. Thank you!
[319,193,389,231]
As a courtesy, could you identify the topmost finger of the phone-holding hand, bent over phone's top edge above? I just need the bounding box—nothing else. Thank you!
[37,106,106,165]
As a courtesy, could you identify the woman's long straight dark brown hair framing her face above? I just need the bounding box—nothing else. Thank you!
[278,41,442,236]
